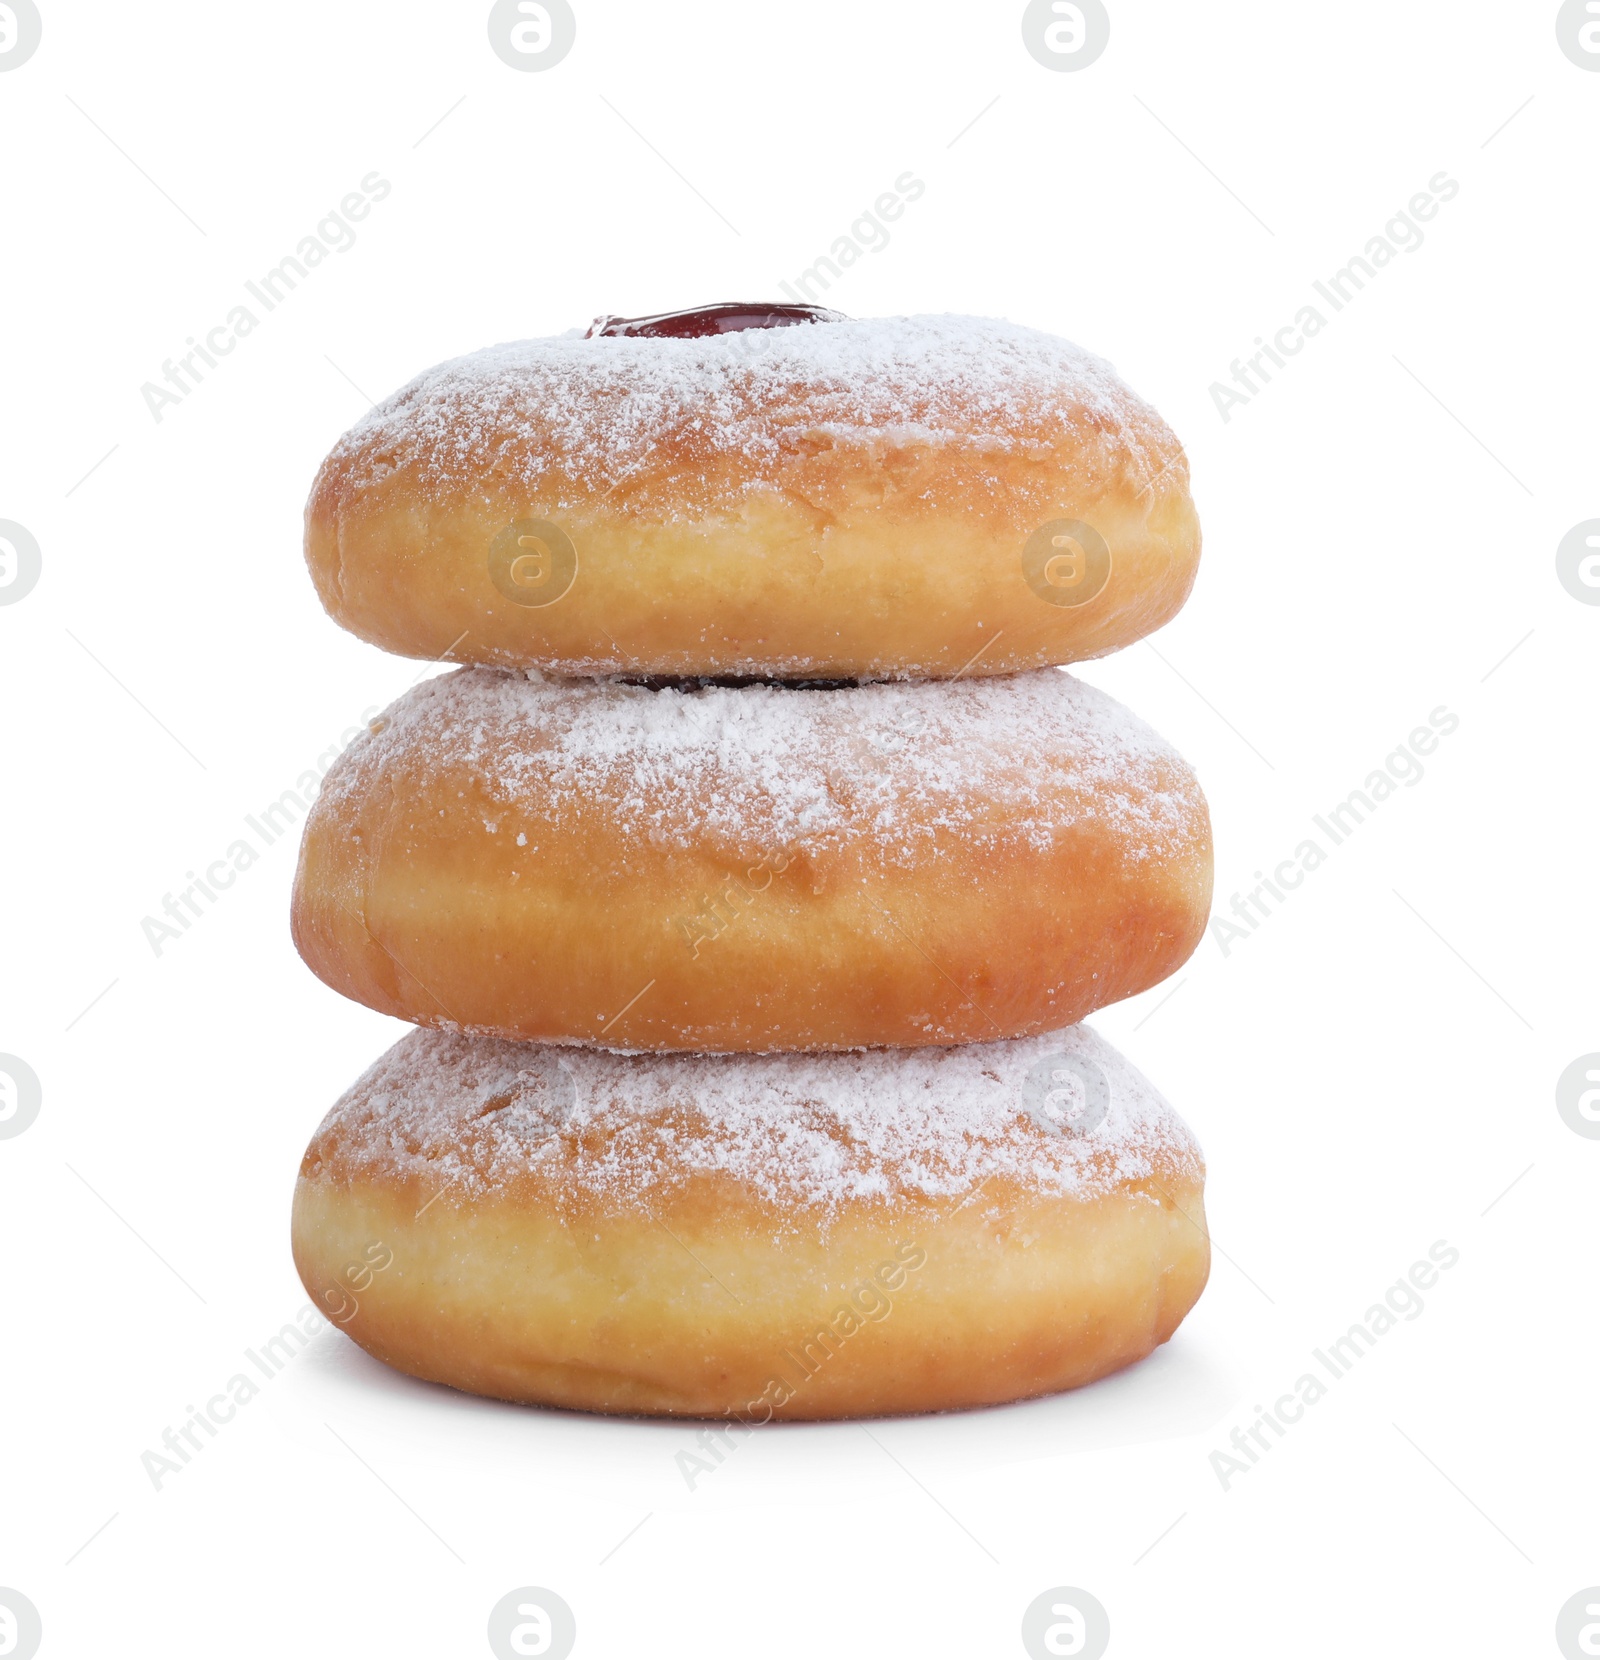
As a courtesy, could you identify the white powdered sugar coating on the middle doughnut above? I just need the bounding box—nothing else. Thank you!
[324,664,1207,863]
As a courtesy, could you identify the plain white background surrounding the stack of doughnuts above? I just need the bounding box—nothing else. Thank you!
[0,0,1600,1657]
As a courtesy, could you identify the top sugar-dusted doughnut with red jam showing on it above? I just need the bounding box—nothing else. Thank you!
[305,304,1200,679]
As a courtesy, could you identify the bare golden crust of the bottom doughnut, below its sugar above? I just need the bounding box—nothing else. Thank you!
[294,1179,1210,1424]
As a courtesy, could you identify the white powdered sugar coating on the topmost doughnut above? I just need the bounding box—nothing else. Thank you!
[318,315,1187,515]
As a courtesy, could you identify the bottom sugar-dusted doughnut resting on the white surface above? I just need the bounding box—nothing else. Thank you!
[292,1026,1210,1424]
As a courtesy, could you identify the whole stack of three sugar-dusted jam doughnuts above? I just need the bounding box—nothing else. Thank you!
[292,304,1212,1426]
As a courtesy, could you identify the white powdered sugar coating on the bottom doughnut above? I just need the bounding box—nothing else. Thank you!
[302,1026,1203,1225]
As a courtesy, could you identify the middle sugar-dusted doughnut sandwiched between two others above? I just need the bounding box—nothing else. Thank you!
[294,669,1212,1051]
